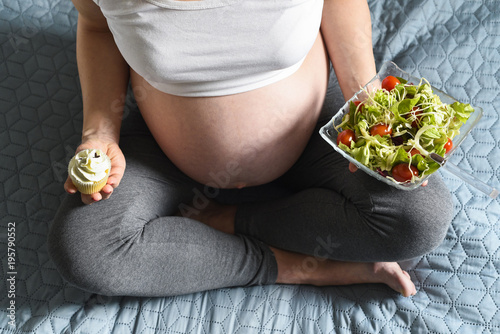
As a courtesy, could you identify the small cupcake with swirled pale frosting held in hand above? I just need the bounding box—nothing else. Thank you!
[68,149,111,194]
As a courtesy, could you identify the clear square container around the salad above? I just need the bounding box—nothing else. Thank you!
[319,61,483,190]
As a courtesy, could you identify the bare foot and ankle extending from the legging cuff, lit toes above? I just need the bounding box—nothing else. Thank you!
[271,248,416,297]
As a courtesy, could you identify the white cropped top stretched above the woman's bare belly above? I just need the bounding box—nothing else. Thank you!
[94,0,323,96]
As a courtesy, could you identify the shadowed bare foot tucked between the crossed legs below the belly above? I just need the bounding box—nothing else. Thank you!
[178,201,236,234]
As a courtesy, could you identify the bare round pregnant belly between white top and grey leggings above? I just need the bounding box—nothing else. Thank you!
[131,36,328,188]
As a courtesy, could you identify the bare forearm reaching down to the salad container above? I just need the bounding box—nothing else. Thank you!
[321,0,376,99]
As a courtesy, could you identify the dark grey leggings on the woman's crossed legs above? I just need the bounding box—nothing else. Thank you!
[49,73,453,296]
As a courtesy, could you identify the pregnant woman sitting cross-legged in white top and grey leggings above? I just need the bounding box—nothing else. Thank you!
[49,0,453,296]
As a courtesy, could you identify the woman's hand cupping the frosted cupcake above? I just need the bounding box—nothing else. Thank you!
[64,139,126,204]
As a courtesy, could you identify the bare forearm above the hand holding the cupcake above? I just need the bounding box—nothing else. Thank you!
[76,18,129,142]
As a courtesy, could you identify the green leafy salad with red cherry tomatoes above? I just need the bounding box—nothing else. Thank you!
[335,76,474,183]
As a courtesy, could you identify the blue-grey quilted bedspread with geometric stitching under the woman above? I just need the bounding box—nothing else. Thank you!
[0,0,500,333]
